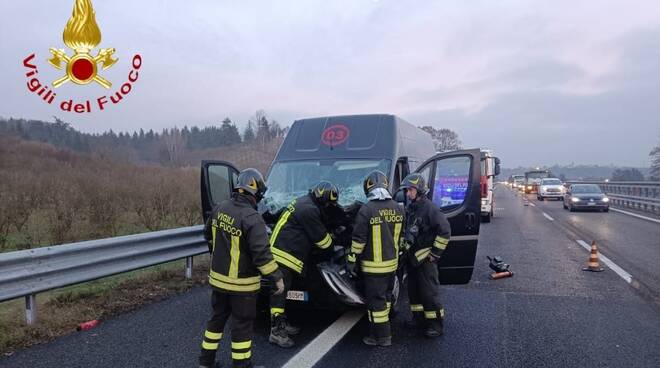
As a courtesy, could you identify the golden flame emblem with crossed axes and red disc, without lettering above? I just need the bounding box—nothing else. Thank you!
[48,0,117,88]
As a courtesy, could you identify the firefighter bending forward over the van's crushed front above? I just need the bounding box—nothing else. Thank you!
[268,181,339,348]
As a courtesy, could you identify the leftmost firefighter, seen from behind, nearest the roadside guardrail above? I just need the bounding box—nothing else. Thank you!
[199,169,284,368]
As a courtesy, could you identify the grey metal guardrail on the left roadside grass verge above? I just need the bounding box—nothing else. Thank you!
[0,225,208,324]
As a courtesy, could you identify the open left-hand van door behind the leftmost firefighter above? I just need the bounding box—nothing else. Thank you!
[200,160,238,223]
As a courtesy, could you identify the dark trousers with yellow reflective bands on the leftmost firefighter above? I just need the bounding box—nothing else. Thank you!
[199,290,257,366]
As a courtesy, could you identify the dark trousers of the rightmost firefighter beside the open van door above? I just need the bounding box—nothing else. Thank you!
[408,260,445,331]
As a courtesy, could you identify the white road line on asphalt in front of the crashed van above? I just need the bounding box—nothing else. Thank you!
[282,311,364,368]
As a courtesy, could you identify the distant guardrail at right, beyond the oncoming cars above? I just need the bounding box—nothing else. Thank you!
[567,181,660,215]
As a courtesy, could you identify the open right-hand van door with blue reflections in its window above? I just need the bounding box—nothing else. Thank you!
[417,149,481,284]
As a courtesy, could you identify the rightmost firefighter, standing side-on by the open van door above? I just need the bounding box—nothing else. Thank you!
[401,173,451,337]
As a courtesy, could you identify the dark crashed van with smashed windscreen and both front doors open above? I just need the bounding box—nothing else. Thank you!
[201,115,481,309]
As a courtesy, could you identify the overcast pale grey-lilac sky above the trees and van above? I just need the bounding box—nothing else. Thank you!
[0,0,660,167]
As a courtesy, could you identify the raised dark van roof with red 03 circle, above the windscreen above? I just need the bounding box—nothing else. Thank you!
[275,114,433,161]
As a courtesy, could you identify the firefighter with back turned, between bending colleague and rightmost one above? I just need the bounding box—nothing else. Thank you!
[347,171,404,346]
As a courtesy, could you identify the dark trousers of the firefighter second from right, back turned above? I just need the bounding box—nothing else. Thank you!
[364,273,394,338]
